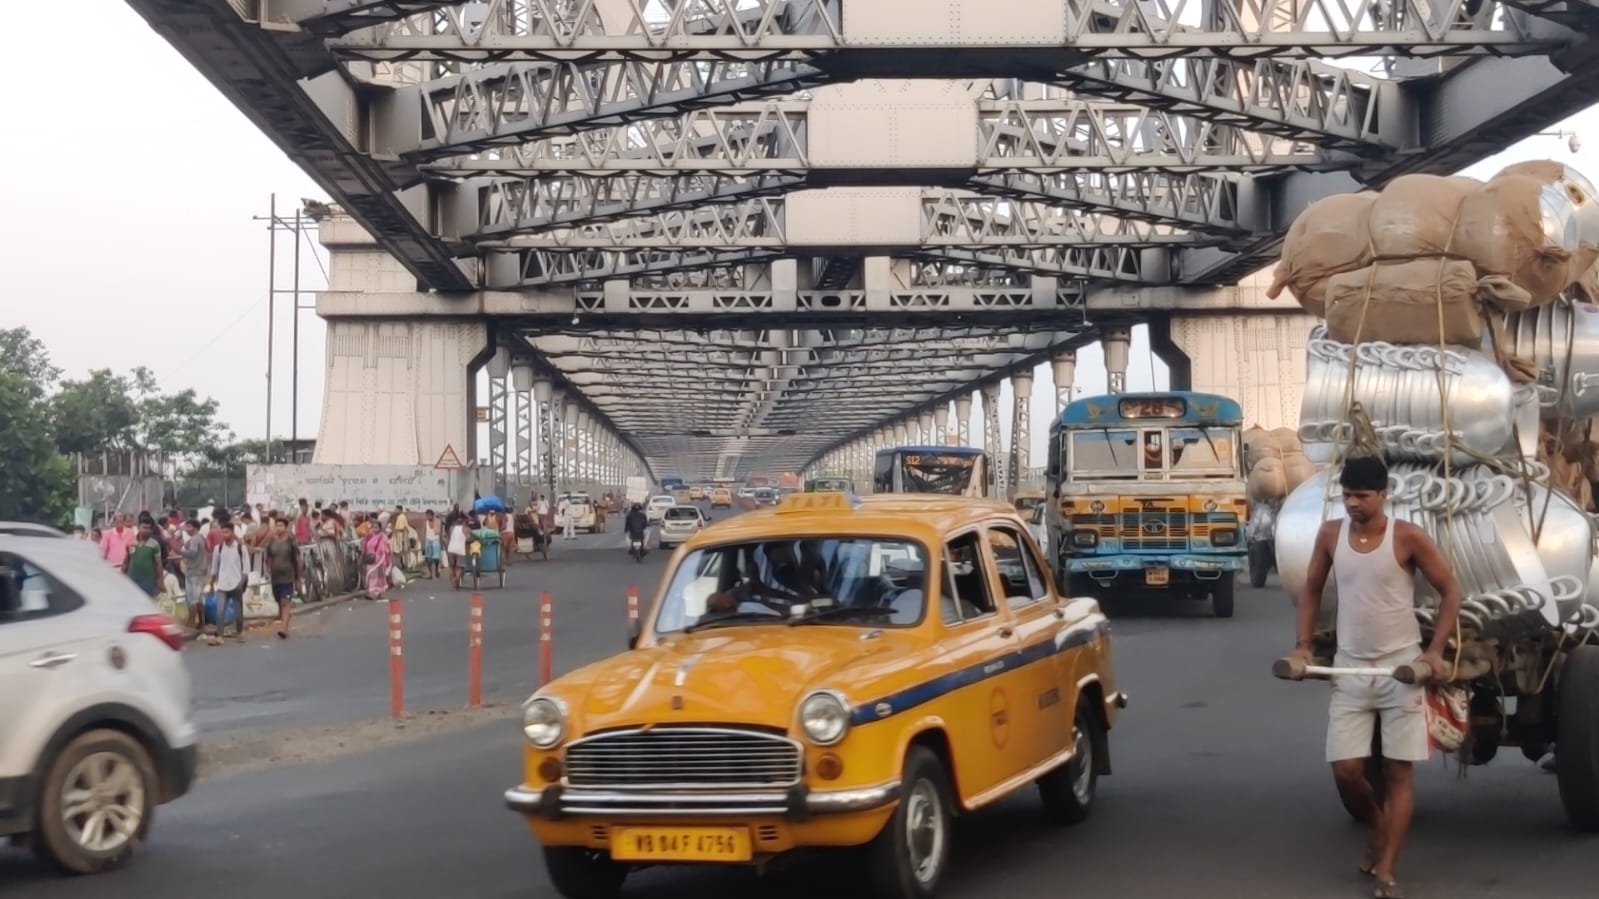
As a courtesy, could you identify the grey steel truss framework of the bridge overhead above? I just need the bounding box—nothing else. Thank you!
[128,0,1599,477]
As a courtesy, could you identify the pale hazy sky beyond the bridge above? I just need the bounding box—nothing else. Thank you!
[0,0,1599,459]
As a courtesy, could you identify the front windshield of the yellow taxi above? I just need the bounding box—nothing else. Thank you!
[656,537,927,633]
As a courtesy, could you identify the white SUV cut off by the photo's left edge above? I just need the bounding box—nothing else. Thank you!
[0,523,198,873]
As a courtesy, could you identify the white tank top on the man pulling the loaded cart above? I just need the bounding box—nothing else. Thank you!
[1332,518,1422,659]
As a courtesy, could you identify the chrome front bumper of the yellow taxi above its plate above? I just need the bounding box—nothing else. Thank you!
[505,781,900,821]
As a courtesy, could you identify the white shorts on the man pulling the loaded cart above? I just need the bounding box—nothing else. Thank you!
[1327,646,1431,761]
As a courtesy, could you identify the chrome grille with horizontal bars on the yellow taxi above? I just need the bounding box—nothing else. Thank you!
[566,728,803,789]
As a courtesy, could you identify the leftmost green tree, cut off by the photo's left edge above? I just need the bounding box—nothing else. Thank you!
[0,328,74,525]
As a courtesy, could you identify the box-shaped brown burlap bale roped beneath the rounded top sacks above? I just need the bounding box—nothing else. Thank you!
[1327,259,1482,347]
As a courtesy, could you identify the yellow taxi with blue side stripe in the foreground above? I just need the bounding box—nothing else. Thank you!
[505,493,1126,899]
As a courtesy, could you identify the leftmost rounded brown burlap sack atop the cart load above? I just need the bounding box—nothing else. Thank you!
[1266,192,1377,315]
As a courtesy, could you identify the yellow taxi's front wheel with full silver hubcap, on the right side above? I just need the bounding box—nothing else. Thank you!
[867,745,955,899]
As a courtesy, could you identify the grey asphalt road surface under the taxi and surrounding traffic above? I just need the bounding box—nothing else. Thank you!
[0,508,1599,899]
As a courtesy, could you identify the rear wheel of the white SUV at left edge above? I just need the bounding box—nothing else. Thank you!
[34,729,158,873]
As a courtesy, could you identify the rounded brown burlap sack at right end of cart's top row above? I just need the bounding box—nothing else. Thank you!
[1455,174,1586,304]
